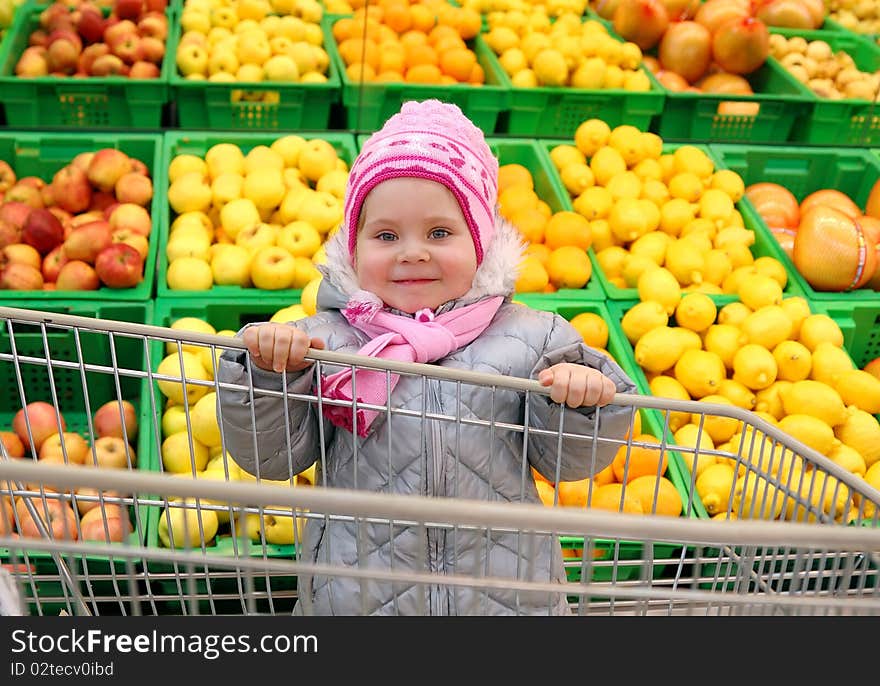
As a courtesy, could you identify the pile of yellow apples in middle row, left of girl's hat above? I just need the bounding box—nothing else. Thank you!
[165,134,348,290]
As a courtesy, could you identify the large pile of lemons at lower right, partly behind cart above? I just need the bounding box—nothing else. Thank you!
[621,276,880,521]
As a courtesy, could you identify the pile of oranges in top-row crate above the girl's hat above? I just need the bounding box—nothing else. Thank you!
[333,0,485,85]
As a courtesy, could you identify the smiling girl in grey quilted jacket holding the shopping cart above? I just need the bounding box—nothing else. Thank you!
[219,100,634,615]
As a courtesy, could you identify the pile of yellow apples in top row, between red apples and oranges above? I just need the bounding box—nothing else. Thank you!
[175,0,330,86]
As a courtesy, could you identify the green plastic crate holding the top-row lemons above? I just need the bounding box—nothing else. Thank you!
[477,37,664,138]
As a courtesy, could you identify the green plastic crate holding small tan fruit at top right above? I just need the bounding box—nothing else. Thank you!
[771,28,880,146]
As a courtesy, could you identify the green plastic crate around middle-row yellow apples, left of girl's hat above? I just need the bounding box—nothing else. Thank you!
[156,131,357,304]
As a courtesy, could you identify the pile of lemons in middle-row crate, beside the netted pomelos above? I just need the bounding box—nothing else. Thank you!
[550,119,772,294]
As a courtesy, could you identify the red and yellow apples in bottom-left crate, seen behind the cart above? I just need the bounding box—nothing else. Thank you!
[0,400,138,542]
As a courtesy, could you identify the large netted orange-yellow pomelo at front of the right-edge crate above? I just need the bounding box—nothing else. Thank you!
[792,205,877,291]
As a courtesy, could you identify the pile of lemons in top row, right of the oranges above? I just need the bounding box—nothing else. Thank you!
[483,11,651,91]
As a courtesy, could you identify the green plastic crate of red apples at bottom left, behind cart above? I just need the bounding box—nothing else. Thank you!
[0,300,157,607]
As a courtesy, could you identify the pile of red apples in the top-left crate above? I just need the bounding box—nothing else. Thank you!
[15,0,168,79]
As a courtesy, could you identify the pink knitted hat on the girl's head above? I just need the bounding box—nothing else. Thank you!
[343,100,498,264]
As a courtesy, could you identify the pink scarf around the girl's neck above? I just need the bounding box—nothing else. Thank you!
[321,291,504,438]
